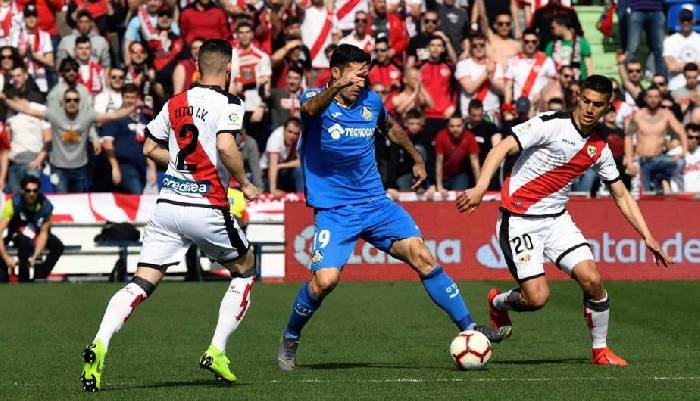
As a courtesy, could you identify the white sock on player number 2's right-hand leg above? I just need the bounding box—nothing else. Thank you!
[211,276,255,351]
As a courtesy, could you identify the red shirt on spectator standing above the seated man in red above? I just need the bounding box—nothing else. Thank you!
[420,62,457,118]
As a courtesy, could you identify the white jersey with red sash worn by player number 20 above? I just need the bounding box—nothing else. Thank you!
[501,112,620,216]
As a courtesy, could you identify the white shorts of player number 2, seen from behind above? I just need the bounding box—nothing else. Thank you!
[137,201,250,271]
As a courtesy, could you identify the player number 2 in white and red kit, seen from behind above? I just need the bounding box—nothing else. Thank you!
[81,39,258,391]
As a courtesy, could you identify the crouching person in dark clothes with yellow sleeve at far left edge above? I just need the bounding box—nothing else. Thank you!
[0,176,63,283]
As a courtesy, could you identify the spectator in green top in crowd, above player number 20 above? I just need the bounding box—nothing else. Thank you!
[545,17,593,81]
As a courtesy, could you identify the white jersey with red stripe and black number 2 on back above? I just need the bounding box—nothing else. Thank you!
[146,86,244,208]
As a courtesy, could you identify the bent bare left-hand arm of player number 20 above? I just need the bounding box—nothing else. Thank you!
[457,136,520,213]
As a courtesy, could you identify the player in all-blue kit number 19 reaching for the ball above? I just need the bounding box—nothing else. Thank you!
[277,44,510,370]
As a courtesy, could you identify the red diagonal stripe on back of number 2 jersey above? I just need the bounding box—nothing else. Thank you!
[168,91,228,208]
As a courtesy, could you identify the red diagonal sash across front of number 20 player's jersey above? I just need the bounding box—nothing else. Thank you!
[501,133,605,213]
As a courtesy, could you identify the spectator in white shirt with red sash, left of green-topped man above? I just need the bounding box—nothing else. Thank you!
[504,29,557,103]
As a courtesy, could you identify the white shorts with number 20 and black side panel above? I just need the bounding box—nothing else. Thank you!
[496,209,593,283]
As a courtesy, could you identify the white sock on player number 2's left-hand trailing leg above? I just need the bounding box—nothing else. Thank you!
[95,282,148,348]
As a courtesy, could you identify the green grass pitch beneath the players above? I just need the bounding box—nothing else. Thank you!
[0,282,700,401]
